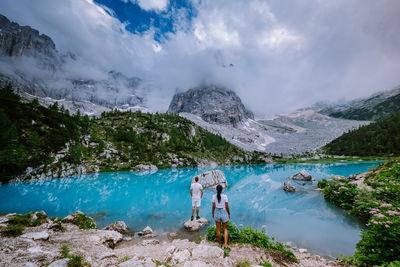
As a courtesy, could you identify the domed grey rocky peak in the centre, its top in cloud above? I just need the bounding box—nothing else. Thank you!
[168,86,254,127]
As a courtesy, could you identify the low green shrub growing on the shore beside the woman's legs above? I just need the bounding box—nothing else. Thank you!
[206,222,297,262]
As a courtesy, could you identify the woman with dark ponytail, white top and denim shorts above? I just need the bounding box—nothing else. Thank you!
[212,185,231,249]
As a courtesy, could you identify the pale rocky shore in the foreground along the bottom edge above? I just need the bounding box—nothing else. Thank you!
[0,213,352,267]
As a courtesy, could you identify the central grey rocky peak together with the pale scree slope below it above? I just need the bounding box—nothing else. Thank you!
[168,86,369,155]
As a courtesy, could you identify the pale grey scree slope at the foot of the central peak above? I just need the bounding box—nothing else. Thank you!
[179,110,369,155]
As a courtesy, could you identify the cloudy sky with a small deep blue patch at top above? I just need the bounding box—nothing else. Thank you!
[0,0,400,116]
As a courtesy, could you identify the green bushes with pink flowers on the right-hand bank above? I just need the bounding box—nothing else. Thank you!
[322,158,400,266]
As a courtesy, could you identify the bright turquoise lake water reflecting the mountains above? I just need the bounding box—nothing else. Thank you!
[0,161,379,257]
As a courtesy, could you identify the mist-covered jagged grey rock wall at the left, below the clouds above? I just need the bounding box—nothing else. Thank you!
[0,15,147,115]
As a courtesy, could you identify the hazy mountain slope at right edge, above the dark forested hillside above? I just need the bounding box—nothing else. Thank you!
[317,87,400,120]
